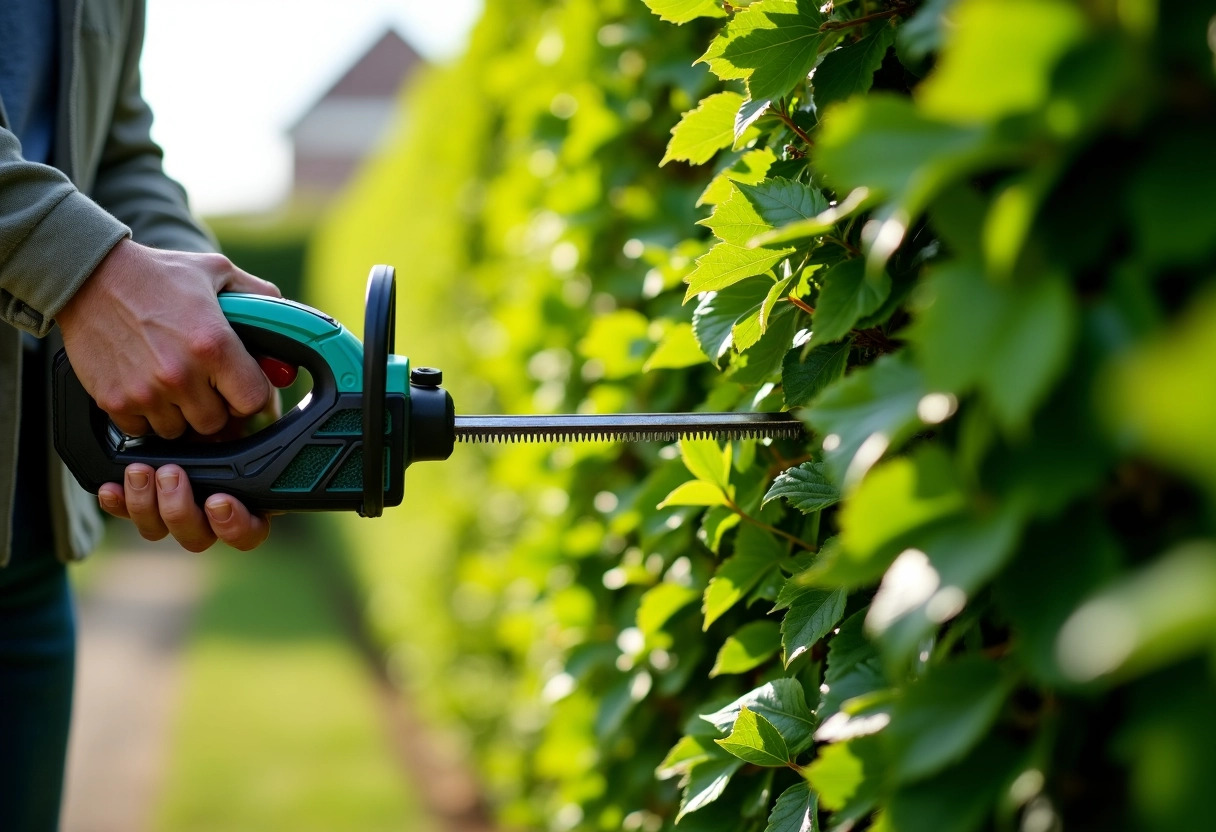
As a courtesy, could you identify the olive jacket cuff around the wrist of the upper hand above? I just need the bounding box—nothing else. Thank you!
[0,190,131,337]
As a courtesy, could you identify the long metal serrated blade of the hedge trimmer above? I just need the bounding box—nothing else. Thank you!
[456,414,803,443]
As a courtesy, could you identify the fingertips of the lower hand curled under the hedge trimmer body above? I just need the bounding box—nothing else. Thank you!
[97,463,270,552]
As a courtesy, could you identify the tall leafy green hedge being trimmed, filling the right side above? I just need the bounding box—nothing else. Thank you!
[311,0,1216,832]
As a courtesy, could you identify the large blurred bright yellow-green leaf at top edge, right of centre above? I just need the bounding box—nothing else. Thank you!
[917,0,1088,123]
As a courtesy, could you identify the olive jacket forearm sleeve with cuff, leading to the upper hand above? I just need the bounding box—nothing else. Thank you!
[0,128,130,336]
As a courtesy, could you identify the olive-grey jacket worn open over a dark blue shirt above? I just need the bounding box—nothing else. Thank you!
[0,0,215,566]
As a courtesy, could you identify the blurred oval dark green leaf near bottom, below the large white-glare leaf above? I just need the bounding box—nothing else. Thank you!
[884,656,1010,782]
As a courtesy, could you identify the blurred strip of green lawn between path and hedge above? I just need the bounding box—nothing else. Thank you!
[154,518,430,832]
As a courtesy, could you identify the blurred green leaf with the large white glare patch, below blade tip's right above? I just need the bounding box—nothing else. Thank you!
[866,504,1021,665]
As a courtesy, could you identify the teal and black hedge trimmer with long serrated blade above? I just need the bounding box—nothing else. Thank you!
[54,265,803,517]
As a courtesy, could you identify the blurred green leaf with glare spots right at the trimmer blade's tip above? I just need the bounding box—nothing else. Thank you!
[806,355,928,488]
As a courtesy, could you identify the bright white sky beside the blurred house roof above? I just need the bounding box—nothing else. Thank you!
[142,0,482,214]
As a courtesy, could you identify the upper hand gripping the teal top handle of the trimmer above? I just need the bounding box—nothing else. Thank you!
[56,240,281,439]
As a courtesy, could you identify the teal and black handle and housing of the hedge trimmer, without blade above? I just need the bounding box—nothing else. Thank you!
[52,285,406,511]
